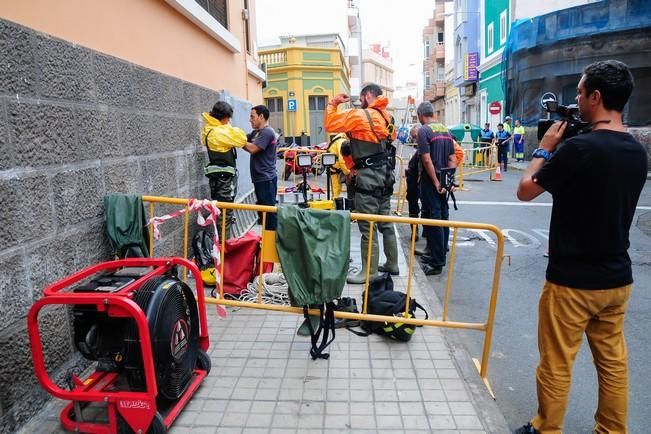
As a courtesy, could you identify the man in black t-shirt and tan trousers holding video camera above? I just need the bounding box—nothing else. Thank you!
[516,60,647,433]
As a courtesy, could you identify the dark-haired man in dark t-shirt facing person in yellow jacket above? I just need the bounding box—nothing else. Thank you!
[244,105,278,230]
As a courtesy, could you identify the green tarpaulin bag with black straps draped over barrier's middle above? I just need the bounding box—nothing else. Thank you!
[276,206,350,359]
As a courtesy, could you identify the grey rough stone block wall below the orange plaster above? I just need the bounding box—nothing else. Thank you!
[0,20,252,433]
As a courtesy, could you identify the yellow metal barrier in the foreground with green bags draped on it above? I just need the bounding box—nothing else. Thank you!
[142,196,504,398]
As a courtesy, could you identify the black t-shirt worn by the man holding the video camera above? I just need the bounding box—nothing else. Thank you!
[533,130,647,289]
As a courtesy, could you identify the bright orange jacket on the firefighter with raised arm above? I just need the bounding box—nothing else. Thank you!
[324,95,395,143]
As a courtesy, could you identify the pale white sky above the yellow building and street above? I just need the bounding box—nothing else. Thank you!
[255,0,434,86]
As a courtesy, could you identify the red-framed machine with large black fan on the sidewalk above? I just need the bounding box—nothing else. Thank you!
[27,258,210,434]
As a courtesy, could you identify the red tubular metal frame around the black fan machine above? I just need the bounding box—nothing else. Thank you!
[27,257,210,434]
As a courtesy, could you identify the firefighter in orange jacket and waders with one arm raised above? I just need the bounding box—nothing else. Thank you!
[325,84,399,283]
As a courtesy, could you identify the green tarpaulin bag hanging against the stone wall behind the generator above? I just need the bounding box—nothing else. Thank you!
[104,194,149,258]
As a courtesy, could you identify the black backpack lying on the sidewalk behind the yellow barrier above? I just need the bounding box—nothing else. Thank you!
[348,273,429,342]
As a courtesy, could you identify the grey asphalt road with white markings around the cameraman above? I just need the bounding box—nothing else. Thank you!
[430,171,651,434]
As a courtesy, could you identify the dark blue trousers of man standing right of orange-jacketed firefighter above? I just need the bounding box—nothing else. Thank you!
[420,174,450,267]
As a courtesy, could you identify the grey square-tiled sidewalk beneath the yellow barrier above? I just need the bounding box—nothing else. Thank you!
[23,225,509,434]
